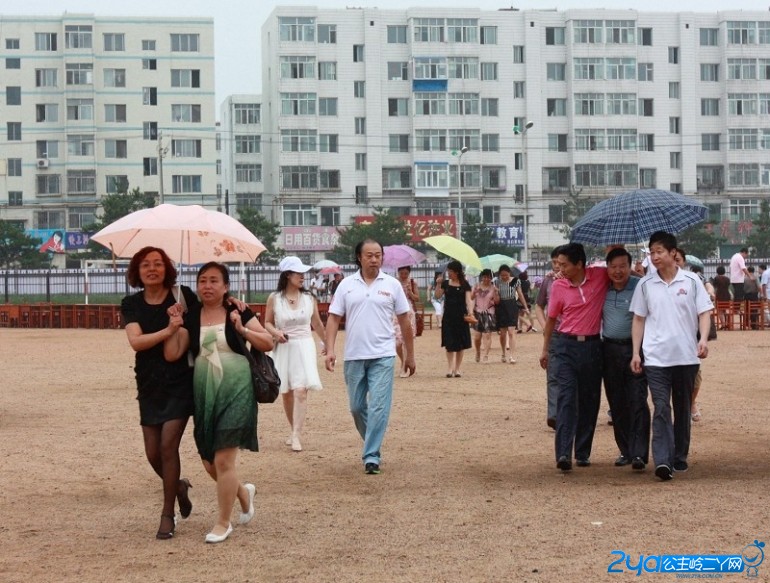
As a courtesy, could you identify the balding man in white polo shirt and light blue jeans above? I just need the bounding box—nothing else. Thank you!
[326,239,415,474]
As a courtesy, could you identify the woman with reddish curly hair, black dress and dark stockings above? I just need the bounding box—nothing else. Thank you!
[121,247,198,540]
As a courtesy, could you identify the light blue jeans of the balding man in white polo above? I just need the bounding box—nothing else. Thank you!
[345,356,396,464]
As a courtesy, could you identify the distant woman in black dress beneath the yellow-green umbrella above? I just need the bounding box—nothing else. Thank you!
[434,261,475,378]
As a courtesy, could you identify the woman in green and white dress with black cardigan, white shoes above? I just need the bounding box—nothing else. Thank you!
[164,262,273,543]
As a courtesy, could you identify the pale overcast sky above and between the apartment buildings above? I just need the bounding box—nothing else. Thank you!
[9,0,770,110]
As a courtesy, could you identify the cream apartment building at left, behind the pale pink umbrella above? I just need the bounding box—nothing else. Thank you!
[0,13,217,248]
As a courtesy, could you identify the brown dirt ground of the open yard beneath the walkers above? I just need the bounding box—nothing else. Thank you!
[0,329,770,583]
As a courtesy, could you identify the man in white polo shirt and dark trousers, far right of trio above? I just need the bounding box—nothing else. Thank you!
[630,231,713,481]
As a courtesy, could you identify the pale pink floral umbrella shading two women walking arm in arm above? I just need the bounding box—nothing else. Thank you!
[91,204,265,265]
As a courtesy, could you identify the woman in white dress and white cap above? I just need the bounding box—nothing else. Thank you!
[265,256,325,451]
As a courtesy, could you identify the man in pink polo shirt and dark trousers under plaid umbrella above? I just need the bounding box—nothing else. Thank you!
[540,243,609,472]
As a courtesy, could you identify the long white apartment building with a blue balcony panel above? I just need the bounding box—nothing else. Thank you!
[249,7,770,258]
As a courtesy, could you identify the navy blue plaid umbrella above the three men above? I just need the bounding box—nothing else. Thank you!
[570,189,707,245]
